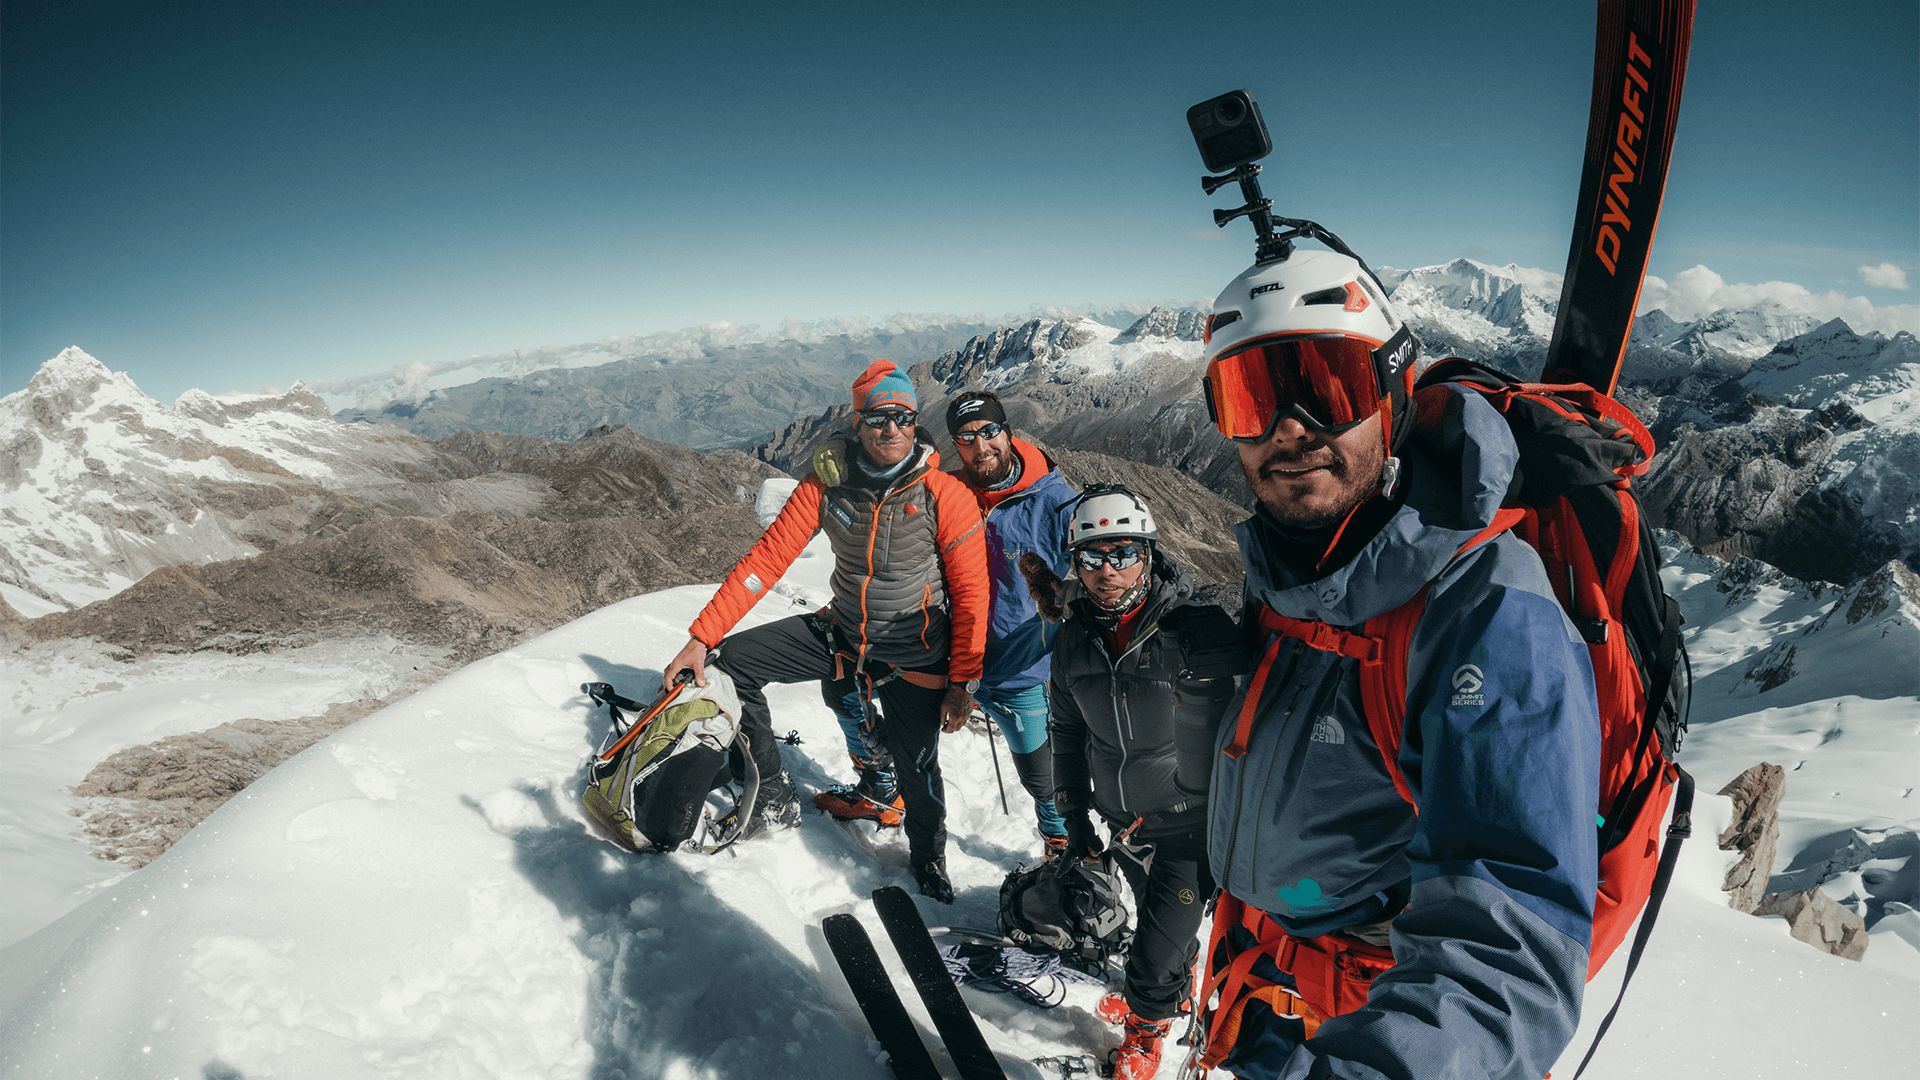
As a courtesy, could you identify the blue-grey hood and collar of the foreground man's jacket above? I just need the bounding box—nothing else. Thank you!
[1235,388,1519,626]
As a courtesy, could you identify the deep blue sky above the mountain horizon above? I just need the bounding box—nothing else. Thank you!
[0,0,1920,400]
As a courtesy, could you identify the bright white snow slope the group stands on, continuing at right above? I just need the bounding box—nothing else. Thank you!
[0,515,1920,1080]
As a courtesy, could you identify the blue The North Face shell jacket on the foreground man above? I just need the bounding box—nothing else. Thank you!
[1210,384,1599,1080]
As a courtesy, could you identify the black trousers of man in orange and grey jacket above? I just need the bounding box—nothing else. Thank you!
[716,615,947,863]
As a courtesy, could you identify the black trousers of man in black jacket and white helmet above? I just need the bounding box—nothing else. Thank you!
[1102,815,1213,1020]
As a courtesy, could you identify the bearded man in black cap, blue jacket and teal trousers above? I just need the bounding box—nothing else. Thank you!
[814,390,1077,857]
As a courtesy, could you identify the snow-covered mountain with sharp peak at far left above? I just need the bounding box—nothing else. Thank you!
[0,348,480,617]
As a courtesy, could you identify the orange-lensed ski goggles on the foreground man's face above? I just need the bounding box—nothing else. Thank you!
[1204,327,1415,442]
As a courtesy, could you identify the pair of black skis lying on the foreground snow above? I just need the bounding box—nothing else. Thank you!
[820,886,1006,1080]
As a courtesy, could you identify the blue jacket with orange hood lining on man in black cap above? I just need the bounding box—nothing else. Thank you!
[960,438,1079,690]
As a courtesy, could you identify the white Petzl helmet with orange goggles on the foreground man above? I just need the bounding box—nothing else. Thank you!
[1206,250,1419,454]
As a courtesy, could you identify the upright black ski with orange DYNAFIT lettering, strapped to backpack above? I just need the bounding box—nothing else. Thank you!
[1540,0,1693,394]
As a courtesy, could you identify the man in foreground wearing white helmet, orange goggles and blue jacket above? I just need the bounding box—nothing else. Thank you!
[1202,248,1599,1080]
